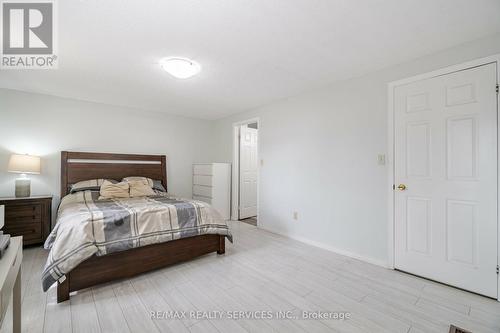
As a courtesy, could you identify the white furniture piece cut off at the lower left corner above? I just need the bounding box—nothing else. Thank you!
[0,237,23,333]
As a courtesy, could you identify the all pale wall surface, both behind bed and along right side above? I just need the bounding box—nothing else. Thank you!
[0,35,500,264]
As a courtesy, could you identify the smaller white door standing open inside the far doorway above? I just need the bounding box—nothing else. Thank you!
[239,125,258,219]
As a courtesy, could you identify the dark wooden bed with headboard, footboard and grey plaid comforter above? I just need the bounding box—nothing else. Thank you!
[42,151,232,303]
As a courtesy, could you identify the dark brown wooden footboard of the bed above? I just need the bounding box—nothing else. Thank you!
[57,235,226,303]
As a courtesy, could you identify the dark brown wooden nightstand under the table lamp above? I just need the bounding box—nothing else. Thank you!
[0,195,52,245]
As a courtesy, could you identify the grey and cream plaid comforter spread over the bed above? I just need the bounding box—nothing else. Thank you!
[42,191,232,291]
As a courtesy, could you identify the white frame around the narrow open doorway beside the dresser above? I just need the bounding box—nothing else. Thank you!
[231,117,261,220]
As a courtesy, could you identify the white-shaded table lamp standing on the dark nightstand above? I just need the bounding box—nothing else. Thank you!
[7,155,40,198]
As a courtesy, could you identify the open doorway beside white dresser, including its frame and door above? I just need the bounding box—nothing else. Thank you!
[231,119,259,226]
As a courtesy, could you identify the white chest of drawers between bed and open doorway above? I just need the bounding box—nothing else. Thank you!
[193,163,231,220]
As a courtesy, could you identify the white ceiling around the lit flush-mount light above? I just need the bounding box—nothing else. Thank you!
[0,0,500,119]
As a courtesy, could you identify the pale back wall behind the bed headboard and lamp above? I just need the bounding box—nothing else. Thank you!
[0,89,212,222]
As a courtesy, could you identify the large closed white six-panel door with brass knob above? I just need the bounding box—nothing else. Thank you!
[394,64,498,298]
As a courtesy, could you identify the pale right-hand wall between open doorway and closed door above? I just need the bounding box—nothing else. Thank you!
[214,35,500,264]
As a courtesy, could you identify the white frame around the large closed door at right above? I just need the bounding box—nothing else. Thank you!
[387,54,500,301]
